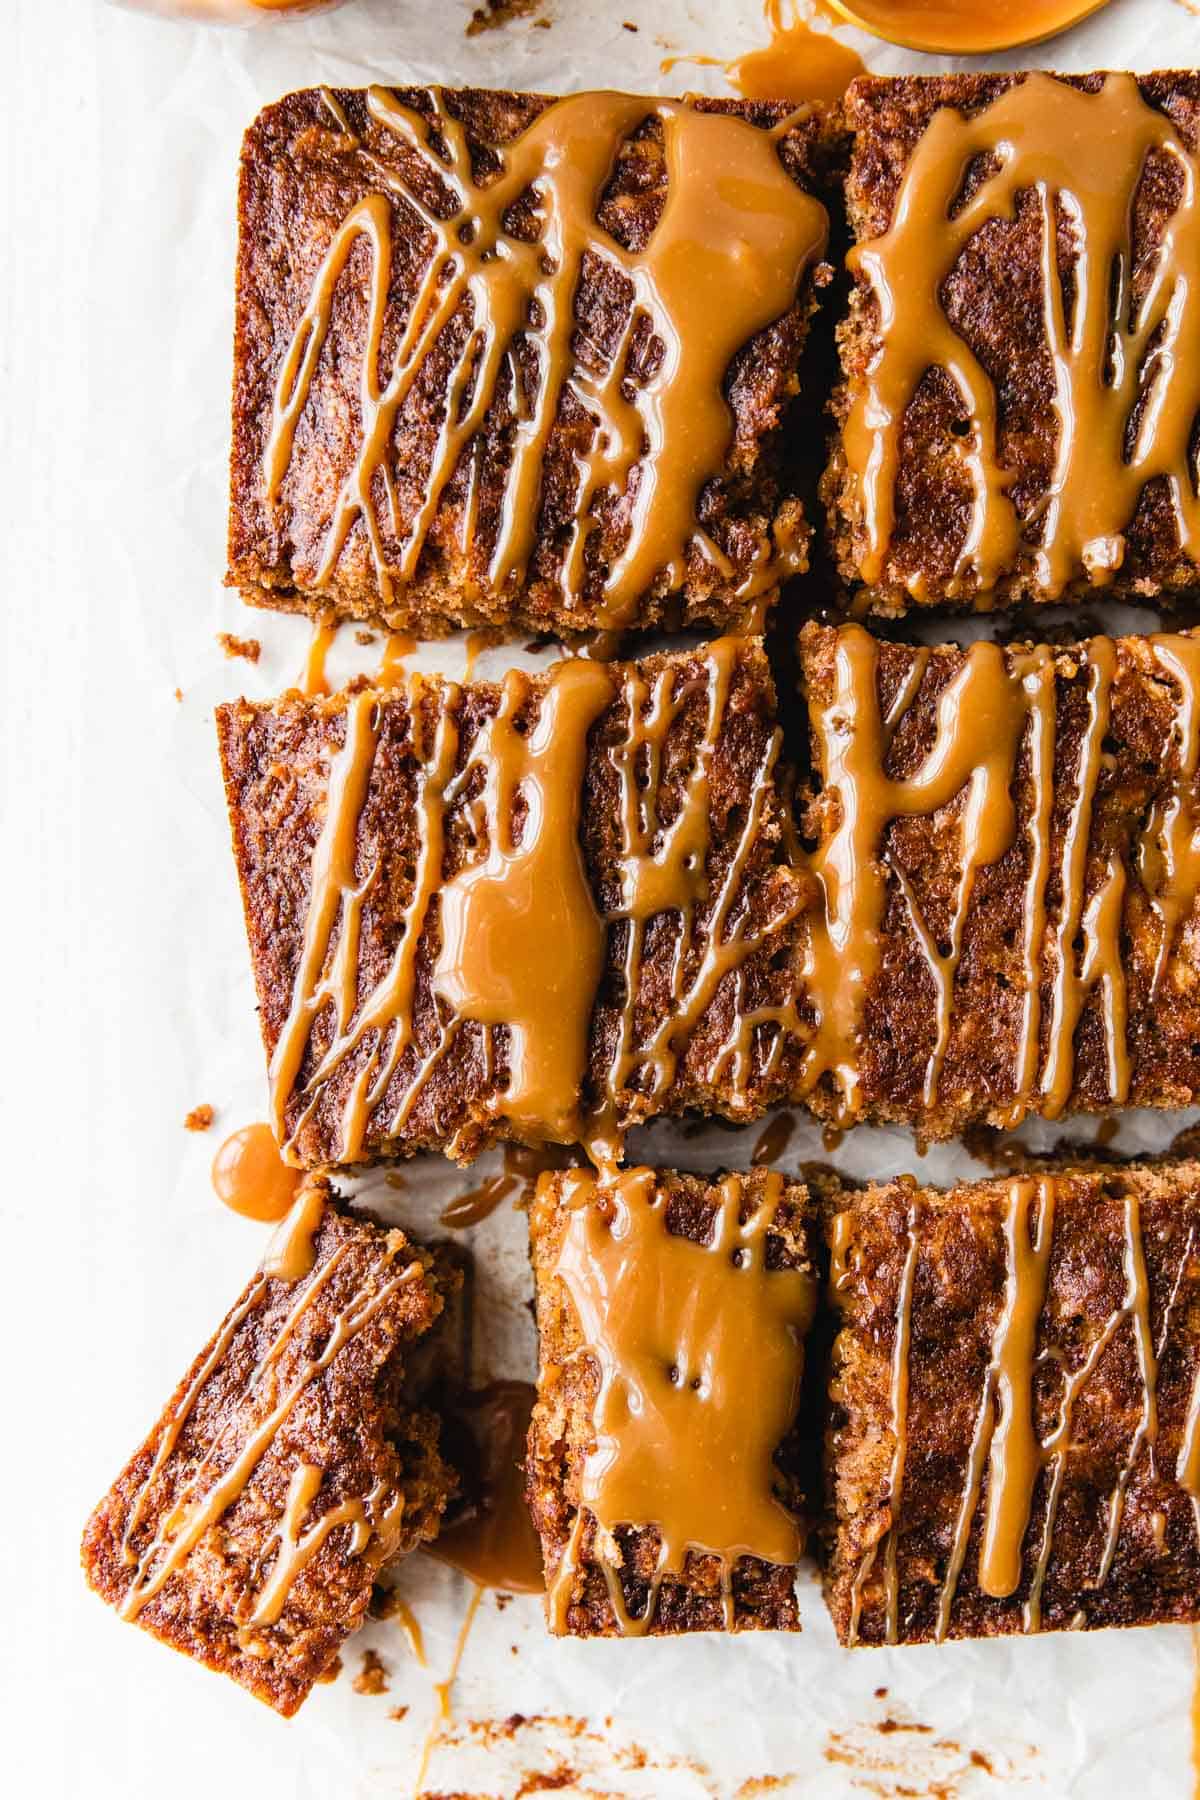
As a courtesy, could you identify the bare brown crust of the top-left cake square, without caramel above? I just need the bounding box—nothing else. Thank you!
[228,88,826,635]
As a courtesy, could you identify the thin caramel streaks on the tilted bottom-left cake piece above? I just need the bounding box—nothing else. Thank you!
[121,1244,421,1618]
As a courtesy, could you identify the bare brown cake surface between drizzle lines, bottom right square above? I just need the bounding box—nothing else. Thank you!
[824,1163,1200,1643]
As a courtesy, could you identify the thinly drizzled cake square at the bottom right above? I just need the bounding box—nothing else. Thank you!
[824,1163,1200,1645]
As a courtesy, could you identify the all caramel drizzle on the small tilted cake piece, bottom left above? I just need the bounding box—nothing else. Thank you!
[121,1246,423,1627]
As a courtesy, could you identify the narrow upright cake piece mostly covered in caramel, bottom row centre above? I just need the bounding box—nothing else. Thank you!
[525,1168,817,1638]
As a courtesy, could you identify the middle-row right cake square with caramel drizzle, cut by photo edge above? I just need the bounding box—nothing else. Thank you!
[795,625,1200,1139]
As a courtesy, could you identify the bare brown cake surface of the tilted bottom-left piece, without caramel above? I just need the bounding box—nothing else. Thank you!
[83,1208,455,1715]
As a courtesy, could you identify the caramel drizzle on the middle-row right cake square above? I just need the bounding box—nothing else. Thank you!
[799,625,1200,1125]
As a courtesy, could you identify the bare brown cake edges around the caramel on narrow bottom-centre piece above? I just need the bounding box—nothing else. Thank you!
[525,1168,815,1638]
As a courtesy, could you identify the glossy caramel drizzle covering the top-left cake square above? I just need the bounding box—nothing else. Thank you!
[263,88,828,625]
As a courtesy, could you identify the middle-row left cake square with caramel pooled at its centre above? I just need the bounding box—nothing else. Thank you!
[218,639,813,1166]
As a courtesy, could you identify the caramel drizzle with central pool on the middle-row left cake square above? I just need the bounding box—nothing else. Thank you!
[272,639,799,1163]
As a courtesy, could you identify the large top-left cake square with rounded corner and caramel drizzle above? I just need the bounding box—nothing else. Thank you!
[228,86,829,635]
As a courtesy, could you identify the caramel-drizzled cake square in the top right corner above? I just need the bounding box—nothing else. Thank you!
[824,70,1200,614]
